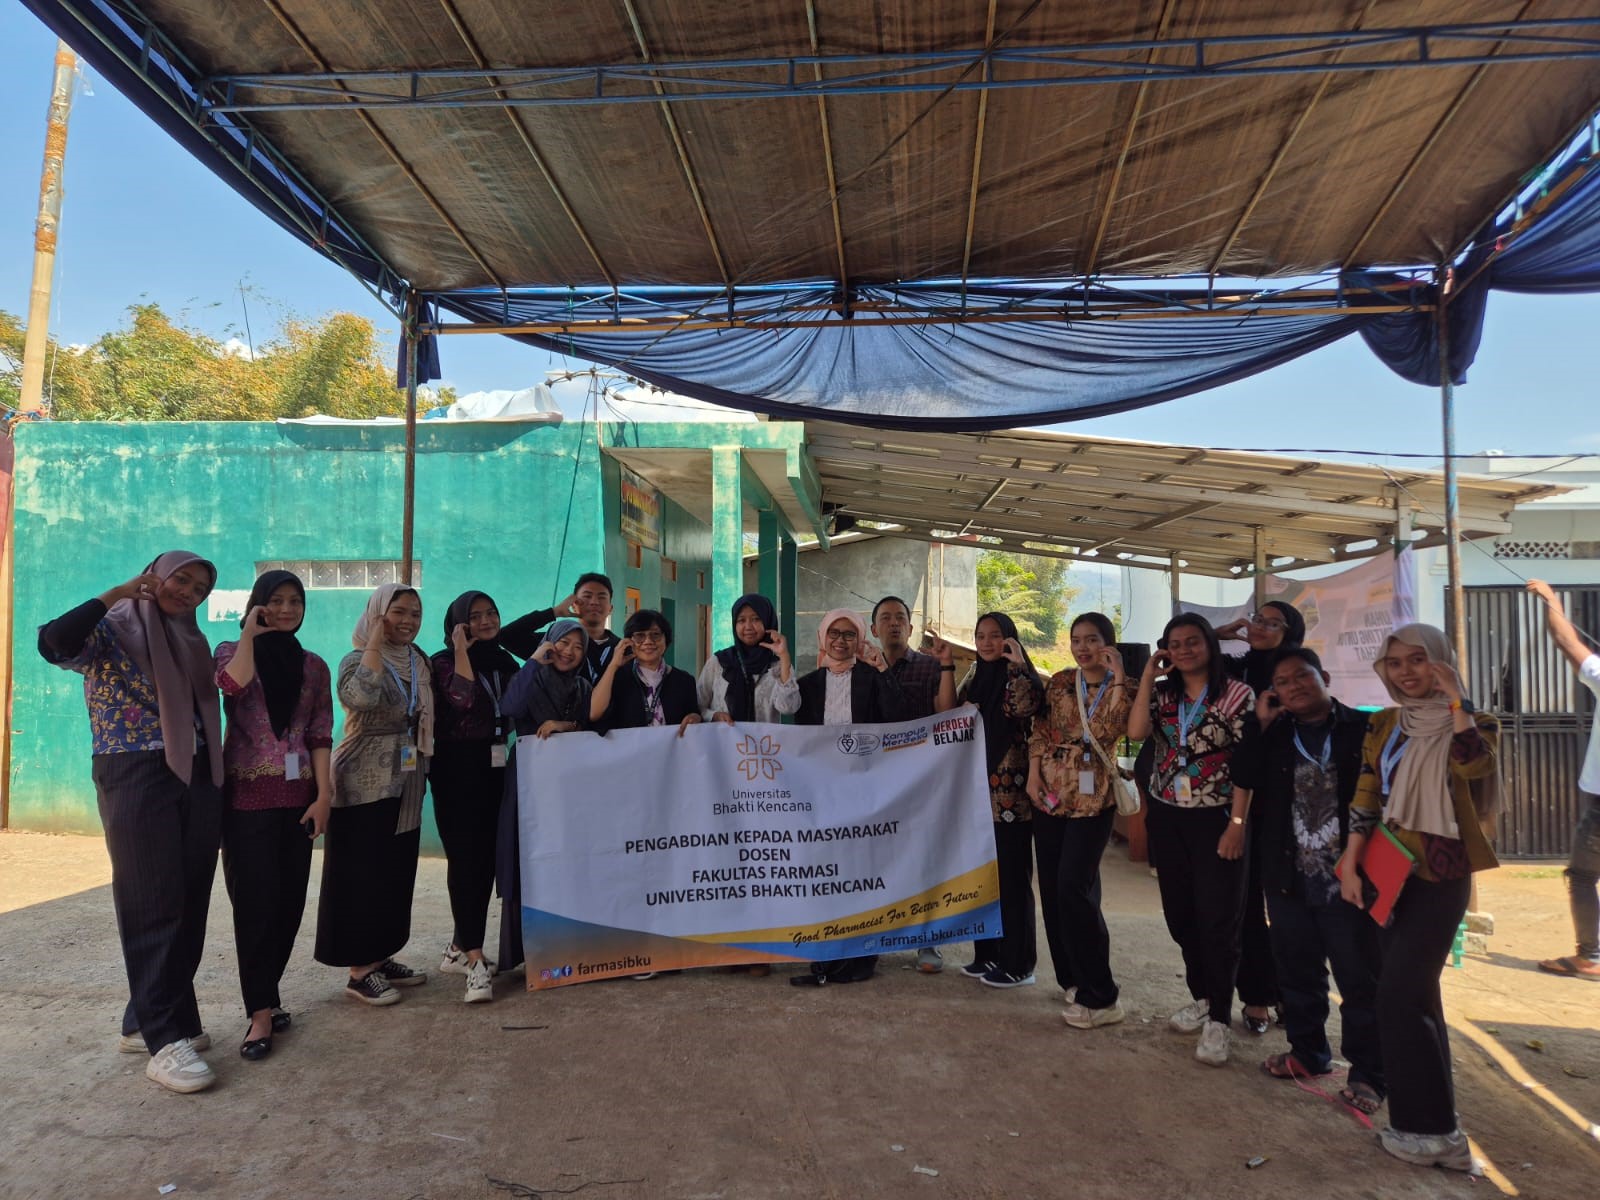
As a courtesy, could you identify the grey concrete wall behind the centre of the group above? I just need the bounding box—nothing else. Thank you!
[742,538,978,649]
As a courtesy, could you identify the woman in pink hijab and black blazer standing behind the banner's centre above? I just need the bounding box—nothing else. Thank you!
[789,608,902,987]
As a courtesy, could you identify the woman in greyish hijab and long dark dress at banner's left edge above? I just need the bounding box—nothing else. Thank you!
[494,616,598,971]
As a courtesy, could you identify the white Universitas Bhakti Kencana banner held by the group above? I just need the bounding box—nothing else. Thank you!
[517,706,1000,990]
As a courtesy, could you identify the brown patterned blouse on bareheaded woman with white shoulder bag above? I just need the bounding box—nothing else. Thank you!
[1027,667,1139,816]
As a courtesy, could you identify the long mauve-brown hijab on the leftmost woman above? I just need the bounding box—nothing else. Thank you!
[106,550,222,787]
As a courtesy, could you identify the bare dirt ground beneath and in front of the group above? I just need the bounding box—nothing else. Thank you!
[0,834,1600,1200]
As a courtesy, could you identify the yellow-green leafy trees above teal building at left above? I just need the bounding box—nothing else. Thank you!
[0,304,454,421]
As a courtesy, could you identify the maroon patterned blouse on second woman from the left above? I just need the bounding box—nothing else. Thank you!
[213,642,333,810]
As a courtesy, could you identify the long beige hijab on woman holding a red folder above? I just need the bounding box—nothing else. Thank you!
[1373,624,1499,838]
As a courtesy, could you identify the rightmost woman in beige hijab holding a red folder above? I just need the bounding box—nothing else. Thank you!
[1338,626,1499,1171]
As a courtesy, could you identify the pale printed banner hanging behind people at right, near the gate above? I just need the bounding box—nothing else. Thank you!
[1182,549,1416,707]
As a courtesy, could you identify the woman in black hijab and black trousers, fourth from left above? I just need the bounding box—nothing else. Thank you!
[427,592,533,1005]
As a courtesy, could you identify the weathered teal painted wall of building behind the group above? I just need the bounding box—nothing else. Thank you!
[10,422,738,846]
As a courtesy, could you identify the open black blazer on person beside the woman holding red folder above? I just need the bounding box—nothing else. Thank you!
[1229,701,1366,894]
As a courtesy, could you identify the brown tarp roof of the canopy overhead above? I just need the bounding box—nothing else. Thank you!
[106,0,1600,291]
